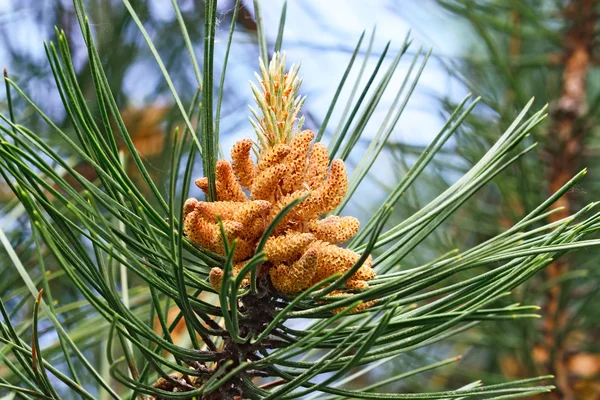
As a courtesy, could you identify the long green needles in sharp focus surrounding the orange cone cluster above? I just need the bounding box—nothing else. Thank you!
[0,0,600,399]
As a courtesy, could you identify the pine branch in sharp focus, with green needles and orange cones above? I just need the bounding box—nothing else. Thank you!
[0,0,600,400]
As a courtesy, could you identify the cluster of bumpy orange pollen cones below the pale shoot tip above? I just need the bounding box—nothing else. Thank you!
[184,130,375,308]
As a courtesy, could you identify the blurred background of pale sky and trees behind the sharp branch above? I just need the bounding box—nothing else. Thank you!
[0,0,600,399]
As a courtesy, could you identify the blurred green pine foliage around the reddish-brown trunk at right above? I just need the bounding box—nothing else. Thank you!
[412,0,600,392]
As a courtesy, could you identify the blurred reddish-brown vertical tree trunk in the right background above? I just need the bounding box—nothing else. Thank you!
[535,0,598,400]
